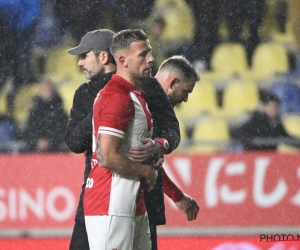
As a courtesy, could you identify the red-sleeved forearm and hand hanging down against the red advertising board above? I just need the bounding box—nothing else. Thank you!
[161,168,200,221]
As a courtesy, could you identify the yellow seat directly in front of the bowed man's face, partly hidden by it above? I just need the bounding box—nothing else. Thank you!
[175,80,218,120]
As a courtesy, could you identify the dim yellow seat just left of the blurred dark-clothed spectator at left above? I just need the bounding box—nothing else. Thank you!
[13,83,38,126]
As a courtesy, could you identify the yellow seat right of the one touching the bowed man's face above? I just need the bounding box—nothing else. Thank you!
[219,80,259,118]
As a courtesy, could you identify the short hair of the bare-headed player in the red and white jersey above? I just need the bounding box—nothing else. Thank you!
[110,29,148,56]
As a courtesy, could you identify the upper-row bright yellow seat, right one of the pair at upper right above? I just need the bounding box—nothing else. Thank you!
[249,43,289,81]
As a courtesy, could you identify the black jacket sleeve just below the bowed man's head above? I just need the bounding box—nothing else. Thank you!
[140,78,180,154]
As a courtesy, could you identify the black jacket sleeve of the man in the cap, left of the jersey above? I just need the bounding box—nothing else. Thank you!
[65,87,93,154]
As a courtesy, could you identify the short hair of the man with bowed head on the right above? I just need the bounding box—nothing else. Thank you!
[158,55,200,81]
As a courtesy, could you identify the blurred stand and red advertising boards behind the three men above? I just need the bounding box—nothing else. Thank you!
[0,0,300,249]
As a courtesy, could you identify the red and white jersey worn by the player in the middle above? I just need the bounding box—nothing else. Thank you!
[84,75,153,217]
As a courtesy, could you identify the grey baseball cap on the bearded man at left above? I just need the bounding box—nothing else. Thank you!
[68,29,115,55]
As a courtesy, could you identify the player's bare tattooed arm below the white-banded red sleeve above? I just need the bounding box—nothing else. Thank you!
[96,133,157,190]
